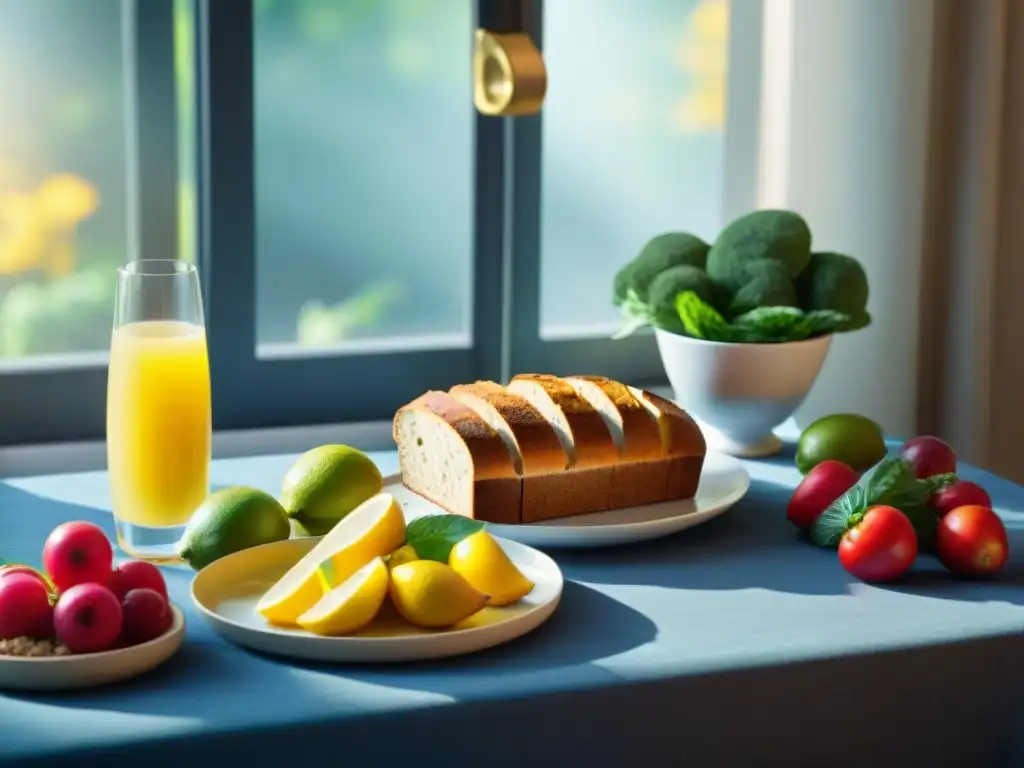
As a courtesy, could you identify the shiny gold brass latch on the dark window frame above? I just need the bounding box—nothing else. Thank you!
[473,0,548,117]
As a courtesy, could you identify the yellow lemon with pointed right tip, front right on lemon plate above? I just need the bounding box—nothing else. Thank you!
[388,560,487,630]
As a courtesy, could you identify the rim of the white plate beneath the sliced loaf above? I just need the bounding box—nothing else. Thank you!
[383,452,751,549]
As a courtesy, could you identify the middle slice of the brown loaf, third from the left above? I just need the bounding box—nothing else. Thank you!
[508,374,620,516]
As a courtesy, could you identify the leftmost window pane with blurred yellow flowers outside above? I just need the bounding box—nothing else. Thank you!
[0,0,127,366]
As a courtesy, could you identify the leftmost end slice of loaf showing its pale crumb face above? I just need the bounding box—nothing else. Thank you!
[393,392,522,523]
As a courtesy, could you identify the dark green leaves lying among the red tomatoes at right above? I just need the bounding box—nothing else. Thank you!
[811,457,956,552]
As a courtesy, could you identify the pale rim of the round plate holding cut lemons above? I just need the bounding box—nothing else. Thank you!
[189,537,565,664]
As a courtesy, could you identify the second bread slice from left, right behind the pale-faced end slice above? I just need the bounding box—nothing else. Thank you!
[450,381,569,522]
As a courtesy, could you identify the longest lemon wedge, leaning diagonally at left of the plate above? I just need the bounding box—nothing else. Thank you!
[256,494,406,626]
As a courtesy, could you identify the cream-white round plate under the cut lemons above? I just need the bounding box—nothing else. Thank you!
[191,537,562,663]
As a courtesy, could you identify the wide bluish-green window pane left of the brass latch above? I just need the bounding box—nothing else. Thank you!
[255,0,473,354]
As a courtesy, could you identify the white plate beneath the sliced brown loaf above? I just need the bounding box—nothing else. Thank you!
[384,454,751,549]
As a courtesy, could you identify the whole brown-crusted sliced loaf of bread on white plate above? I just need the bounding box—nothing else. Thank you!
[394,374,707,524]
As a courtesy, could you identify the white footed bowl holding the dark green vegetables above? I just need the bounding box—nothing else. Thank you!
[654,329,831,457]
